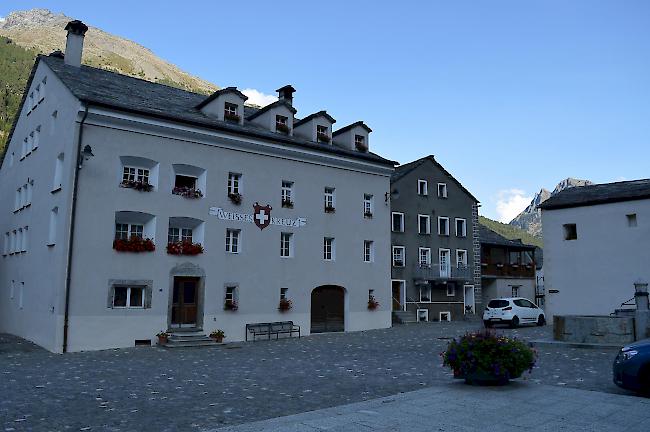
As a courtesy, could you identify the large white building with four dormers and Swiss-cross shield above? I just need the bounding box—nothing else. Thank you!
[0,21,395,352]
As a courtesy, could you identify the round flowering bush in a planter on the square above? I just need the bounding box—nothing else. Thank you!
[441,331,536,380]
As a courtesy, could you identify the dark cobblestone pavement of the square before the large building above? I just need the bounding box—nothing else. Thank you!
[0,322,625,431]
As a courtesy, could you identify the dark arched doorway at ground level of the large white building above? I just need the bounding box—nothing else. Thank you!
[311,285,345,333]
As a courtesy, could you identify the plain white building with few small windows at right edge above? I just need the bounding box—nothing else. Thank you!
[540,180,650,316]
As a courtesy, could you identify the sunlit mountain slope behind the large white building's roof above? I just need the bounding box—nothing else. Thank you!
[0,9,218,151]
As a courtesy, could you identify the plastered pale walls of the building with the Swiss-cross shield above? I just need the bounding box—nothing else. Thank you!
[0,49,392,352]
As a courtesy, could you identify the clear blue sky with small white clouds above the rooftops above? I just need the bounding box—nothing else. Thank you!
[0,0,650,220]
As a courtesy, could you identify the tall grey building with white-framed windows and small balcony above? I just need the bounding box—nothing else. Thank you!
[390,156,481,321]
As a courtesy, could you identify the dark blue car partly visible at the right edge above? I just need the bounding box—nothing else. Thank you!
[613,339,650,395]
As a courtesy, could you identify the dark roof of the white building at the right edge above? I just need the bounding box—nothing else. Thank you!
[538,179,650,210]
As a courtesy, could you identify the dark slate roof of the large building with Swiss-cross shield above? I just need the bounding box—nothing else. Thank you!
[2,55,397,167]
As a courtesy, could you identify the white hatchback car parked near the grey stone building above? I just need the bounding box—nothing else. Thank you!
[483,297,546,328]
